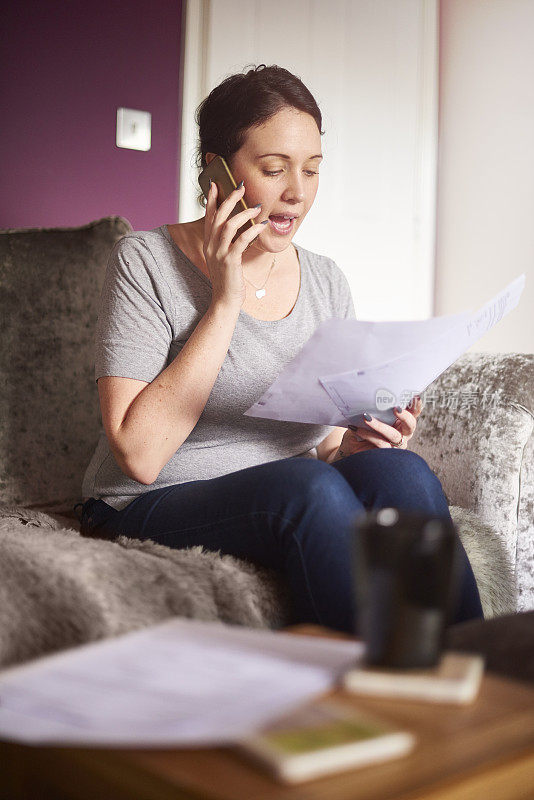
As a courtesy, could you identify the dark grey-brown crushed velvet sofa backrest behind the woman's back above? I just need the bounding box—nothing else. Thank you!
[0,217,131,511]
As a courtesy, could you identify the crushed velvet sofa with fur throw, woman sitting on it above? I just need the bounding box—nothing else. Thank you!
[0,216,534,668]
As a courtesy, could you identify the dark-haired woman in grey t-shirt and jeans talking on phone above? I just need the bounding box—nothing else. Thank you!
[76,65,482,633]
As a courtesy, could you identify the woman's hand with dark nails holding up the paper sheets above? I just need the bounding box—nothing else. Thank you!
[330,395,423,463]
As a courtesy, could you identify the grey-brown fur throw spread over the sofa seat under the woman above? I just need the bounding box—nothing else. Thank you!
[0,507,516,668]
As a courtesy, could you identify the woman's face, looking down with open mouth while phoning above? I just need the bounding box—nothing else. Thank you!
[207,108,322,253]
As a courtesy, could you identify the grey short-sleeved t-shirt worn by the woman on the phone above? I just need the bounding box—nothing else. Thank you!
[82,225,356,510]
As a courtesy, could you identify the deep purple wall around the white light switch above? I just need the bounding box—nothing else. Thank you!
[0,0,182,230]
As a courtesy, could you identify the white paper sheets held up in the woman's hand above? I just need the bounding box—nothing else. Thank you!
[244,273,525,427]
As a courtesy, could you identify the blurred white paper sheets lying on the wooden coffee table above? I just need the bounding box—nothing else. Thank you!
[0,618,363,747]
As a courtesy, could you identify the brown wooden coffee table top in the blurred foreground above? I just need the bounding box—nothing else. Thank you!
[0,625,534,800]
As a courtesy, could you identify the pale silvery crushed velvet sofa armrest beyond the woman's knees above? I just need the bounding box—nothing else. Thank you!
[409,353,534,610]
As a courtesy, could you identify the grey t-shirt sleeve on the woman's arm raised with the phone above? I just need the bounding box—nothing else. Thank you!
[95,236,172,383]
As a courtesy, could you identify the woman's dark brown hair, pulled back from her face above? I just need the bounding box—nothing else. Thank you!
[195,64,324,208]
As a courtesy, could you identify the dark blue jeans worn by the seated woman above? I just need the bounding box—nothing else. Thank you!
[76,448,483,634]
